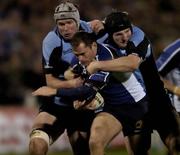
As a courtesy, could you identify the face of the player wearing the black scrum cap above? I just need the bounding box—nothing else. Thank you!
[113,28,132,48]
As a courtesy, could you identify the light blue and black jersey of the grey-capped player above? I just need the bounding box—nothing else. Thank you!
[42,20,92,105]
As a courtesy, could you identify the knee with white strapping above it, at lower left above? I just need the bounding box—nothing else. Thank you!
[29,130,49,155]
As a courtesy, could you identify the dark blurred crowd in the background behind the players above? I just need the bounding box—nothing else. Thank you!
[0,0,180,105]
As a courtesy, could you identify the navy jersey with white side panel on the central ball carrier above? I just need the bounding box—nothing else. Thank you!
[69,44,146,105]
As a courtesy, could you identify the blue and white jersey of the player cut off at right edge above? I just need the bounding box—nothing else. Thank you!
[156,39,180,112]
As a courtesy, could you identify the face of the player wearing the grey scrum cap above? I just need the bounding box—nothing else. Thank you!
[57,19,78,40]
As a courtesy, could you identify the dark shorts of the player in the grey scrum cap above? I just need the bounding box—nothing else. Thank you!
[37,98,95,140]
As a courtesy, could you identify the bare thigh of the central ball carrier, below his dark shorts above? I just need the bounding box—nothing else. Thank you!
[90,112,122,145]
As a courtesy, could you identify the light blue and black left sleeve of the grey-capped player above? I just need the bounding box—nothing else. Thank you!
[42,31,70,78]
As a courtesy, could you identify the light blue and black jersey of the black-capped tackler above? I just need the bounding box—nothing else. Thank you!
[123,27,171,105]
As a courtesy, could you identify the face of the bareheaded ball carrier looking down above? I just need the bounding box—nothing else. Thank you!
[74,43,97,66]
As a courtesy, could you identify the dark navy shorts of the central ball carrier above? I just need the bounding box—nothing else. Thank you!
[103,97,149,136]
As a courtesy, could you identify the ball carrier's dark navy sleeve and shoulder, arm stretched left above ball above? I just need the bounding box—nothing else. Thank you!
[56,44,113,100]
